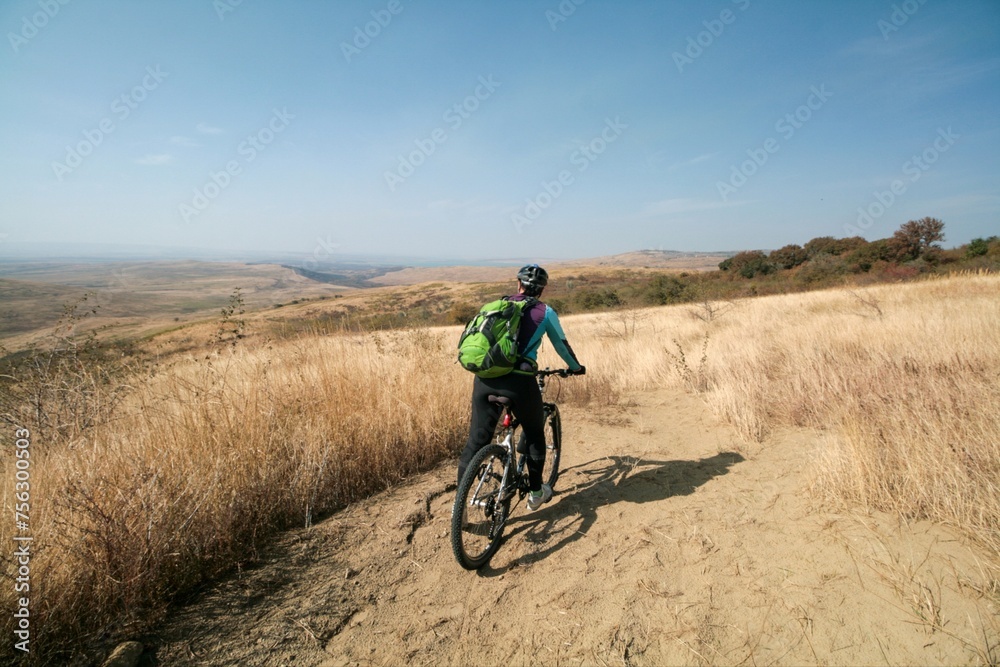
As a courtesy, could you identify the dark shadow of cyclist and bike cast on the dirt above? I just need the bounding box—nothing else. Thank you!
[479,452,744,577]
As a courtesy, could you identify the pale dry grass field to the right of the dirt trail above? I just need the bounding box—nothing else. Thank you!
[566,275,1000,565]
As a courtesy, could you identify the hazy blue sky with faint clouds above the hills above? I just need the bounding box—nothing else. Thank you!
[0,0,1000,259]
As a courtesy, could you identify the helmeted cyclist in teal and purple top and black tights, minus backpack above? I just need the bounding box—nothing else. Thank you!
[458,264,586,512]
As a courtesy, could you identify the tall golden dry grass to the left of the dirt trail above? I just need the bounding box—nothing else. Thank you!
[0,331,470,659]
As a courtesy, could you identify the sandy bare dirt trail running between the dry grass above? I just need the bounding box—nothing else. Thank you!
[147,391,998,666]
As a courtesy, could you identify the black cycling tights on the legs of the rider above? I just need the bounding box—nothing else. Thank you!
[458,373,545,491]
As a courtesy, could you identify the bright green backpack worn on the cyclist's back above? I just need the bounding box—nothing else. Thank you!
[458,297,538,378]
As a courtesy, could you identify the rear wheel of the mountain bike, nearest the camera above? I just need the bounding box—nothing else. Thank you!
[451,445,510,570]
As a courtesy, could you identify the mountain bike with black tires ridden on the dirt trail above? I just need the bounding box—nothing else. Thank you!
[451,368,571,570]
